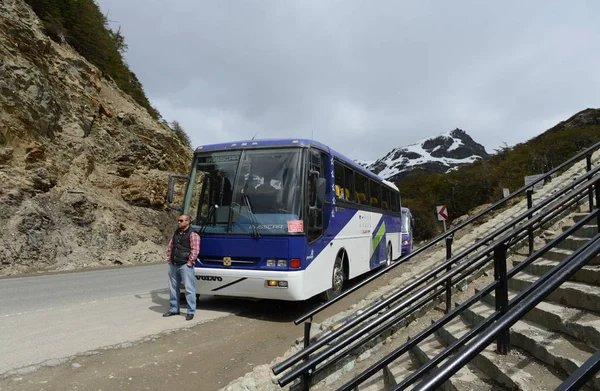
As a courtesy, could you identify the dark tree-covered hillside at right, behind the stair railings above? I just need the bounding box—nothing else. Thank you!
[398,125,600,240]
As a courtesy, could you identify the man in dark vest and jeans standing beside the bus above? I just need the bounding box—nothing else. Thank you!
[163,215,200,320]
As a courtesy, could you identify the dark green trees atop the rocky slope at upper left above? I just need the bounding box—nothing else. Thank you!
[25,0,160,119]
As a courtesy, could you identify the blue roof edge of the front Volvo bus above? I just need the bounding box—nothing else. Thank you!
[195,138,398,191]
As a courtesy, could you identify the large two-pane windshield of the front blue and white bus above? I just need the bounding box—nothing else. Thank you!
[190,148,304,235]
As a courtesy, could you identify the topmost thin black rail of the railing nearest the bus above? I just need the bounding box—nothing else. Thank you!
[294,142,600,325]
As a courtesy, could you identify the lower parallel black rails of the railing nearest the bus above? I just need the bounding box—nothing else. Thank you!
[272,170,600,386]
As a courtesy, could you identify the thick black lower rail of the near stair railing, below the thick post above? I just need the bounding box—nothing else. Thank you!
[410,234,600,391]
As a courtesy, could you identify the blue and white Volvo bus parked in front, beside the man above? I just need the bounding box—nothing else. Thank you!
[167,139,402,301]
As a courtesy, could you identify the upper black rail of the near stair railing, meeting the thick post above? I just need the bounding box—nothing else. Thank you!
[338,207,597,391]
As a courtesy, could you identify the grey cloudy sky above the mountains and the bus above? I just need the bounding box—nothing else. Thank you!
[96,0,600,160]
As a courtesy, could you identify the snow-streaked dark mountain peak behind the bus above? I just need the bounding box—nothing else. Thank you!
[357,128,489,182]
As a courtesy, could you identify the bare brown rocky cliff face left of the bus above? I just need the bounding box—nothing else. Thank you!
[0,0,192,275]
